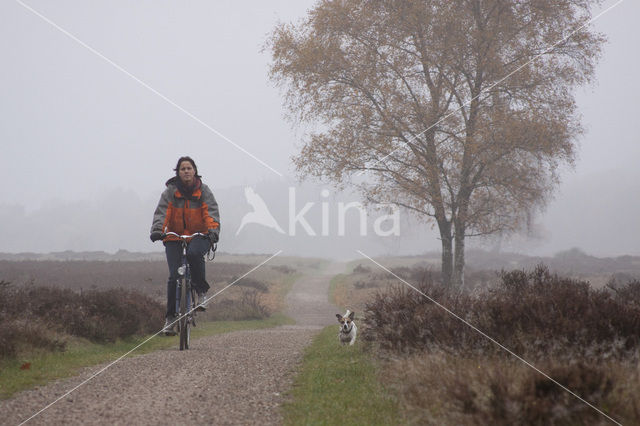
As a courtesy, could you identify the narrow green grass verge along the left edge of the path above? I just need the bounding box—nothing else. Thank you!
[0,314,294,399]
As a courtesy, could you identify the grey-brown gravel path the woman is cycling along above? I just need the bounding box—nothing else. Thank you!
[0,264,344,425]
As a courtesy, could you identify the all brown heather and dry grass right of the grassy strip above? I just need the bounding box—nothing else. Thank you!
[352,265,640,425]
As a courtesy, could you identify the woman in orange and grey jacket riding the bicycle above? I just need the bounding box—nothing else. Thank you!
[150,157,220,333]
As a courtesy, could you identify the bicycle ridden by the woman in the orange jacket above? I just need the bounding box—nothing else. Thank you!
[162,232,209,351]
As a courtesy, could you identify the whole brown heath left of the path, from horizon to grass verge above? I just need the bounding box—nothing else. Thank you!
[0,260,297,358]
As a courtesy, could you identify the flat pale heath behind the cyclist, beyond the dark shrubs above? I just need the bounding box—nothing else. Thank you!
[0,253,322,326]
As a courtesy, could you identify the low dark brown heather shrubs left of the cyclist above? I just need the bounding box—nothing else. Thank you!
[0,283,164,356]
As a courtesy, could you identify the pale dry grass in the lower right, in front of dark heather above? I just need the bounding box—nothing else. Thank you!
[384,351,640,425]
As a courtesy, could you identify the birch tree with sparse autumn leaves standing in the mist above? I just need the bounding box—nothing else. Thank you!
[267,0,604,285]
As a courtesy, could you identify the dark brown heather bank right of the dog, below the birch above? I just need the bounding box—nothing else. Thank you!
[365,265,640,358]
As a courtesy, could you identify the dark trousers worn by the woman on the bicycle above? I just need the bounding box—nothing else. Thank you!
[164,237,210,317]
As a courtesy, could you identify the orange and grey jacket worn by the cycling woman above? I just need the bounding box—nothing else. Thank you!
[151,177,220,241]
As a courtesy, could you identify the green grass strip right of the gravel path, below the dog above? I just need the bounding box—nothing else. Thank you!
[283,326,398,425]
